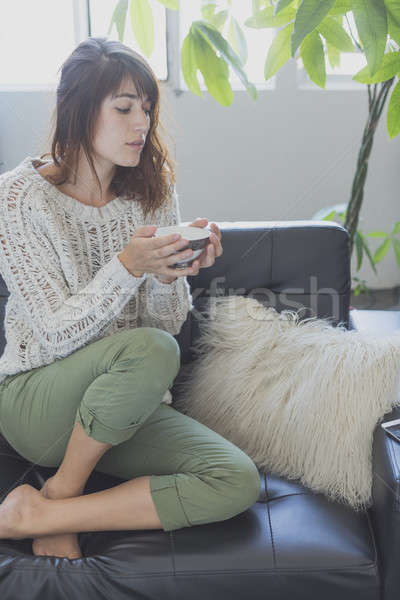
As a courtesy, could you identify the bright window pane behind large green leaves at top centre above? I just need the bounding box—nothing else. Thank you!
[179,0,275,90]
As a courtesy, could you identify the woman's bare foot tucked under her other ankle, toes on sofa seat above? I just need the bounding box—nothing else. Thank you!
[32,476,82,559]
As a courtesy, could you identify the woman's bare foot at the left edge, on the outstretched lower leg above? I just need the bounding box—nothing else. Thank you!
[0,483,45,540]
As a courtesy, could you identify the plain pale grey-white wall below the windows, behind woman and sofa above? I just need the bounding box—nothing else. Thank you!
[0,74,400,289]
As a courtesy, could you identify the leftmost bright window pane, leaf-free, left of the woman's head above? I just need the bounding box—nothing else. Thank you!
[0,0,75,87]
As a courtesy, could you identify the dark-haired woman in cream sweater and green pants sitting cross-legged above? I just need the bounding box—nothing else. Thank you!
[0,38,259,558]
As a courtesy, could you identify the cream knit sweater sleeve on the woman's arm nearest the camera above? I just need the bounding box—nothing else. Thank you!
[0,180,146,358]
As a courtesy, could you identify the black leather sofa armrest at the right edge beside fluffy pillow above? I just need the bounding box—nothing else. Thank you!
[370,398,400,600]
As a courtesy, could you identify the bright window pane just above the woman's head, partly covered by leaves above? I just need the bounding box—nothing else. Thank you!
[90,0,168,81]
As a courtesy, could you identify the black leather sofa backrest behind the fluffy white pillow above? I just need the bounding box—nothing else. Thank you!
[175,220,351,364]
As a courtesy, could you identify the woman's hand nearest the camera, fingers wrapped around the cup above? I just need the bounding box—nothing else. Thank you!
[118,225,194,277]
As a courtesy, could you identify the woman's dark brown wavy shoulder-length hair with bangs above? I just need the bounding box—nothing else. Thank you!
[40,37,176,216]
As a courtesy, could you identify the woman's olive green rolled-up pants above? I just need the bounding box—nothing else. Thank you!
[0,327,260,531]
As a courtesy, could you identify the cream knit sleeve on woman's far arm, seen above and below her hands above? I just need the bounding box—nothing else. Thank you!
[139,186,193,335]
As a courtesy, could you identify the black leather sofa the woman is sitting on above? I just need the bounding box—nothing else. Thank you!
[0,221,400,600]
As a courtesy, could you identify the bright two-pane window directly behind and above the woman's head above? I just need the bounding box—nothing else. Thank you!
[0,0,167,90]
